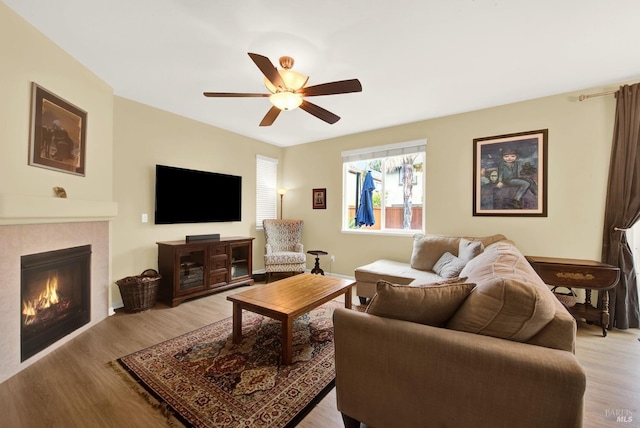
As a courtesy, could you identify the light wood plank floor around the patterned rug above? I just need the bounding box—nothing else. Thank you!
[0,289,640,428]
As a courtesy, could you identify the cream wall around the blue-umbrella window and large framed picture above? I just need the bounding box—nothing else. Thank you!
[283,88,619,275]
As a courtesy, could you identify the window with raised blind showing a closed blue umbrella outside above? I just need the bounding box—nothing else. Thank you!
[342,140,427,233]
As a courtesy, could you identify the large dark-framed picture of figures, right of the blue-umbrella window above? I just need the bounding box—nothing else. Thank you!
[473,129,548,217]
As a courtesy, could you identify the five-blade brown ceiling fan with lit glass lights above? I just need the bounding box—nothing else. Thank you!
[204,53,362,126]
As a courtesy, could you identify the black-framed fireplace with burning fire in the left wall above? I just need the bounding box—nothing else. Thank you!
[20,245,91,361]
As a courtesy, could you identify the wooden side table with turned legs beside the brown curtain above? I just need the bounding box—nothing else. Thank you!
[526,256,620,336]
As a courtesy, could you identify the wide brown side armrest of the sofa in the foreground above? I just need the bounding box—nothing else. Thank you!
[333,308,586,428]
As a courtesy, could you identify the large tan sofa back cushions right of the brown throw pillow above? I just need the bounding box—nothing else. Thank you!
[447,241,556,342]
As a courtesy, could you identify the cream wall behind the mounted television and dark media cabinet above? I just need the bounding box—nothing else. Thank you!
[111,97,283,307]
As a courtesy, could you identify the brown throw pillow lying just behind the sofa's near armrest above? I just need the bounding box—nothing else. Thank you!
[366,278,475,327]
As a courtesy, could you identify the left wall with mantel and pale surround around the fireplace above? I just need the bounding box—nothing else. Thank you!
[0,3,117,380]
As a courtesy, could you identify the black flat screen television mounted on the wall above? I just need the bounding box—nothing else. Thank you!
[155,165,242,224]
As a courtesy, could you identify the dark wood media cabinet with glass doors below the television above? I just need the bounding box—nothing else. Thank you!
[157,237,254,306]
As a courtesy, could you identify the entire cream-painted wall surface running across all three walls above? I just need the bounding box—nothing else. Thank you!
[0,3,636,306]
